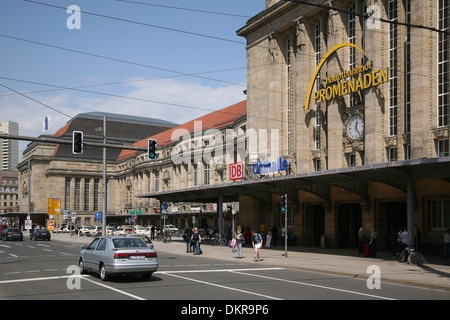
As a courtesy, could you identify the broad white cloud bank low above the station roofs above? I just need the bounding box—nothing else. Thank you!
[0,78,246,156]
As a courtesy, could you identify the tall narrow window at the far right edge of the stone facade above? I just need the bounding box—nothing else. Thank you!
[438,0,450,127]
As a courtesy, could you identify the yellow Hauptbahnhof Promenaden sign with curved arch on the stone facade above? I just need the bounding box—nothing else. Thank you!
[305,43,389,110]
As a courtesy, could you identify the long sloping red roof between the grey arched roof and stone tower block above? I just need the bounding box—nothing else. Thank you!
[117,100,247,160]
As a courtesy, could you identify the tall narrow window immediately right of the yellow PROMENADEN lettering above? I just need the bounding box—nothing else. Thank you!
[388,0,398,136]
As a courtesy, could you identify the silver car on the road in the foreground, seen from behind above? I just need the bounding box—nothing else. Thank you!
[78,236,158,280]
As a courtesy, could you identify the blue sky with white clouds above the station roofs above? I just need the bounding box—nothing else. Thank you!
[0,0,265,155]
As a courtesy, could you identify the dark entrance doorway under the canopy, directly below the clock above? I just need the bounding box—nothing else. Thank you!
[337,203,362,248]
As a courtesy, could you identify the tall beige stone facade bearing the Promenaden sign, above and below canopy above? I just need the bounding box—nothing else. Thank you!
[237,0,450,247]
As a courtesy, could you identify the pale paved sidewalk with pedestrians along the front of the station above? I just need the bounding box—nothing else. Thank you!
[52,233,450,290]
